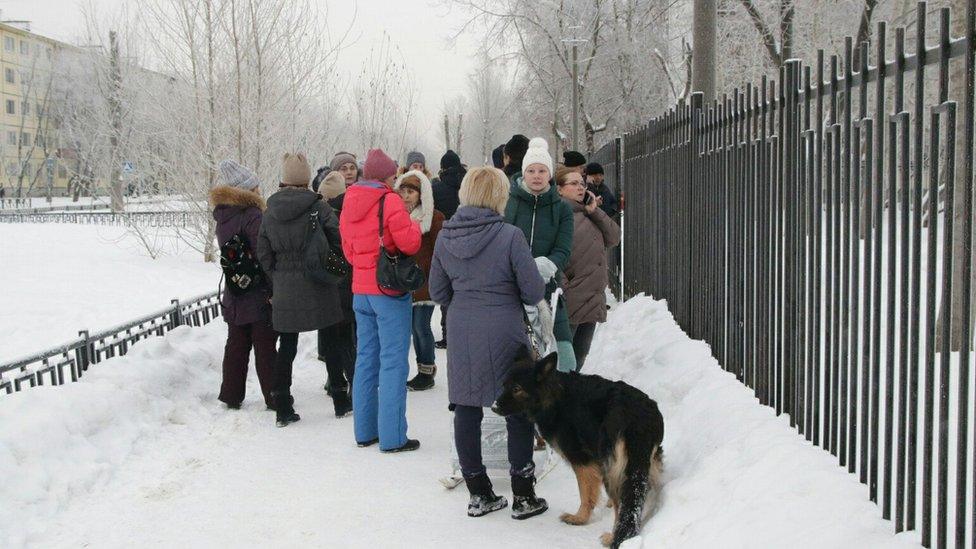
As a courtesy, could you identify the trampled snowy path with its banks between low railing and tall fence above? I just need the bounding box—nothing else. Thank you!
[0,297,918,548]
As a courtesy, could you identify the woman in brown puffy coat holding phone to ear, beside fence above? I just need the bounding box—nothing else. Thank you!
[556,168,620,371]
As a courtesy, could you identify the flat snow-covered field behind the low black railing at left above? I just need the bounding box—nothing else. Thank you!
[0,223,220,362]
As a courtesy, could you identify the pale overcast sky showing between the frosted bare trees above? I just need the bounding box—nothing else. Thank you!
[0,0,478,141]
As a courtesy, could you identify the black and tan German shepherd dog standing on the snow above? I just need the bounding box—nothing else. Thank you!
[492,349,664,547]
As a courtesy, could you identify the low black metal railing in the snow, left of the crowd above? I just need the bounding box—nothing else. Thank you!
[0,292,220,395]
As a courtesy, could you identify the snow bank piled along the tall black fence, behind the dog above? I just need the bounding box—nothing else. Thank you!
[586,296,918,548]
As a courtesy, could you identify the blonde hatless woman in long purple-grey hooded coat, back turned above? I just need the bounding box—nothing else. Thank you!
[429,168,548,519]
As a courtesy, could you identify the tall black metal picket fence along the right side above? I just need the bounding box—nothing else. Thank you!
[597,1,976,548]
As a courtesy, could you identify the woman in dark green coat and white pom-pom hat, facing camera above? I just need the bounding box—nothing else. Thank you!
[505,137,576,372]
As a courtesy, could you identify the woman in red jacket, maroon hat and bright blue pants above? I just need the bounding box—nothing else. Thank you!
[340,149,421,452]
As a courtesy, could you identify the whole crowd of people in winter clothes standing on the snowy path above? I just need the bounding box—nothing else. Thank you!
[210,135,620,519]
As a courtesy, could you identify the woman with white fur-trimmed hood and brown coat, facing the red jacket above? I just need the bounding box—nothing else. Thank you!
[393,170,444,391]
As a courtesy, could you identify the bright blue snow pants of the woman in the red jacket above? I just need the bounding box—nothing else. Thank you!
[352,294,413,450]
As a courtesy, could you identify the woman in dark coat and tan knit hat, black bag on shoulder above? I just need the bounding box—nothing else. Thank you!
[258,153,342,427]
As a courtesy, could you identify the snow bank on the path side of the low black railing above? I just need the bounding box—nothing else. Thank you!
[0,322,226,547]
